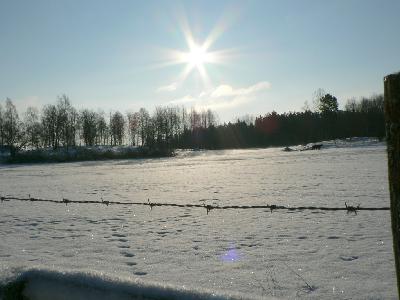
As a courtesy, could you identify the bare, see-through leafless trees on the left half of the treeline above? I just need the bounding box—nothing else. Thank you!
[0,95,216,154]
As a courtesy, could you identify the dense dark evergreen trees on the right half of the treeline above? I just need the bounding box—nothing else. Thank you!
[176,94,385,149]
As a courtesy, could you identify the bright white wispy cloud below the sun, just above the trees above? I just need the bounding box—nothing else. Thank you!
[170,81,271,109]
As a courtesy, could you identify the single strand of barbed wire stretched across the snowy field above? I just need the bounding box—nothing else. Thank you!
[0,195,390,214]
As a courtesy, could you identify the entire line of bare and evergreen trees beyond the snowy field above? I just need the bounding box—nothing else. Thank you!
[0,93,385,156]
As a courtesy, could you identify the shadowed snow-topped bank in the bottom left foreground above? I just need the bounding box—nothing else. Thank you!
[0,269,258,300]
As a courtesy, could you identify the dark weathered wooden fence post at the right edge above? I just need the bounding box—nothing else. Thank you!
[384,72,400,298]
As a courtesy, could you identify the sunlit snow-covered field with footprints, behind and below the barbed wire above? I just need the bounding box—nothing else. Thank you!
[0,140,396,299]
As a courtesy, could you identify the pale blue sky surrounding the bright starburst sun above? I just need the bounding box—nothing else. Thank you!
[0,0,400,121]
